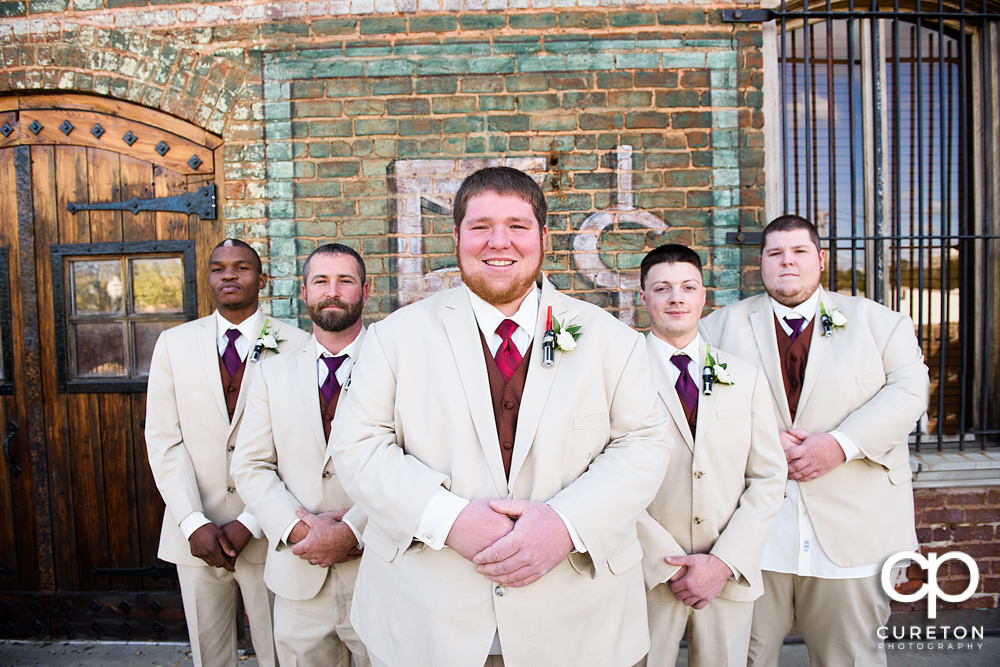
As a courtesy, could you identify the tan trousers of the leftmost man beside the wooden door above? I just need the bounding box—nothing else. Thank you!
[177,556,277,667]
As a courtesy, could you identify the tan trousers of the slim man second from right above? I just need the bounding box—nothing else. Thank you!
[636,584,753,667]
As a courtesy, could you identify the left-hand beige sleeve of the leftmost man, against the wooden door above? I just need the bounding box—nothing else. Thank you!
[145,334,204,524]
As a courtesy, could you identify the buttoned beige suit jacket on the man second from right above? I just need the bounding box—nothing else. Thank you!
[639,334,788,602]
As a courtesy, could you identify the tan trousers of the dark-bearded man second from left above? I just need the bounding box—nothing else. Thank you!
[274,569,371,667]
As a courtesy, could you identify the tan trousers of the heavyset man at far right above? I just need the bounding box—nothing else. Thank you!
[747,570,890,667]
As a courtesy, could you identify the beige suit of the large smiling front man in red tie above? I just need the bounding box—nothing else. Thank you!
[329,280,671,667]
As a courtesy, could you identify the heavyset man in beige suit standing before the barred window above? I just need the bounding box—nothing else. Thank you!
[701,216,929,665]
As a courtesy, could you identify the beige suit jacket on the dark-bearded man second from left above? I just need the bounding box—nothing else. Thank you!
[232,329,367,600]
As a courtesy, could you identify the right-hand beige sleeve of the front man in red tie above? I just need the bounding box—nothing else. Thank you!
[548,334,673,570]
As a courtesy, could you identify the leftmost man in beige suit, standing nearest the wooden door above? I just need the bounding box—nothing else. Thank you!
[146,239,307,667]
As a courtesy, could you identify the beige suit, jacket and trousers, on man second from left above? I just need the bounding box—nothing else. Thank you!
[232,329,368,667]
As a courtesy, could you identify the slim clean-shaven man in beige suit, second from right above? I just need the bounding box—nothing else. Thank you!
[638,244,786,667]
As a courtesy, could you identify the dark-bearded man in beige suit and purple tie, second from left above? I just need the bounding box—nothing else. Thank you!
[233,243,369,667]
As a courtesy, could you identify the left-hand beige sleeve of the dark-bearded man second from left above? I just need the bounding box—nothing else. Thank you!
[231,360,300,545]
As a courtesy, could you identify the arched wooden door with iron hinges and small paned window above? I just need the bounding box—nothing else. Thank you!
[0,95,222,639]
